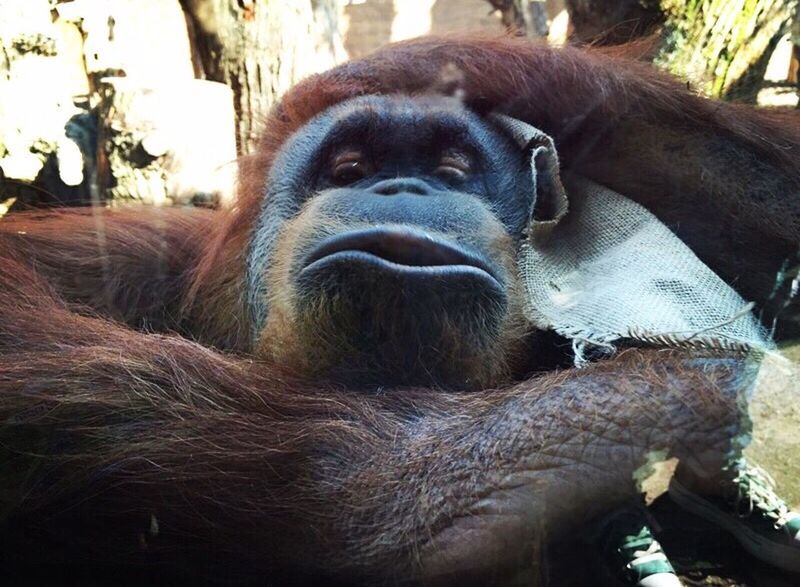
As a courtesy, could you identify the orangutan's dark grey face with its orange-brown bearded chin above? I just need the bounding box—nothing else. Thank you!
[249,97,533,388]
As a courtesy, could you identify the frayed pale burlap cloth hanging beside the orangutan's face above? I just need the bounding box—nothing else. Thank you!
[495,115,771,366]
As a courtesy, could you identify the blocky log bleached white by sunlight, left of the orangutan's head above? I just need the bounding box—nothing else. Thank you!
[97,77,236,206]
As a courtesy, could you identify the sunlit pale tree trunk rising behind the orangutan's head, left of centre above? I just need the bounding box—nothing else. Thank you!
[181,0,345,153]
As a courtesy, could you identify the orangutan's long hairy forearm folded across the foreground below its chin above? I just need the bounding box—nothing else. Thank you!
[0,255,747,579]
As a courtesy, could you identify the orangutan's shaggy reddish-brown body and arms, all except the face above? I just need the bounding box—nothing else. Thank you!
[0,39,800,583]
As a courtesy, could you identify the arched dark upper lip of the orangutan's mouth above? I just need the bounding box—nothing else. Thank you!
[303,227,501,282]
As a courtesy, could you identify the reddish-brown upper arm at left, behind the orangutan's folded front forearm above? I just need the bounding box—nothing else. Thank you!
[0,207,216,330]
